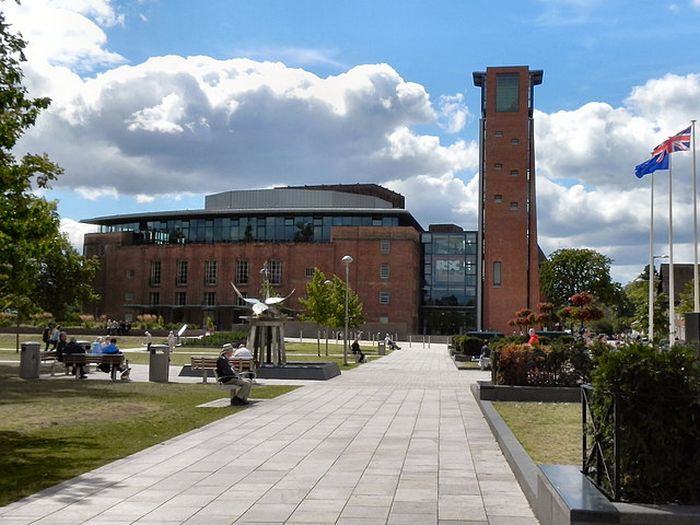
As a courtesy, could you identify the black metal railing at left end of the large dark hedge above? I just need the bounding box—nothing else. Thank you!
[581,385,620,501]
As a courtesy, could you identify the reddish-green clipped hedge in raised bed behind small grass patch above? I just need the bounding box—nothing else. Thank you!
[491,341,592,386]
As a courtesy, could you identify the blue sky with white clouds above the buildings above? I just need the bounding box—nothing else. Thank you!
[5,0,700,284]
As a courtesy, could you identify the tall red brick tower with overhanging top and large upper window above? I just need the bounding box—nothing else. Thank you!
[473,66,543,334]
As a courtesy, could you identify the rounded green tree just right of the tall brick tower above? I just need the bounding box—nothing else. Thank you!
[540,248,620,308]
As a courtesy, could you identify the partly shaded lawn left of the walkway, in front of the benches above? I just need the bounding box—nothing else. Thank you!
[0,365,296,506]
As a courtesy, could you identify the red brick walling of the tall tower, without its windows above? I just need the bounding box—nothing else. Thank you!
[482,67,539,333]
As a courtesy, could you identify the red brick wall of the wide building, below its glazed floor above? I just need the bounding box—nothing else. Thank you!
[85,227,421,331]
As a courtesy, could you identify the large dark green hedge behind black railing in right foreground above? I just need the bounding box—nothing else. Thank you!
[592,344,700,505]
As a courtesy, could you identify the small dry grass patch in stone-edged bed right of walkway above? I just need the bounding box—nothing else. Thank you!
[493,402,581,465]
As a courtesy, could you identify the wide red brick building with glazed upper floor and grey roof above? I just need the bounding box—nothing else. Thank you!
[85,185,422,333]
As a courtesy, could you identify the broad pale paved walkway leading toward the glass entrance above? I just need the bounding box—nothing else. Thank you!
[0,344,537,525]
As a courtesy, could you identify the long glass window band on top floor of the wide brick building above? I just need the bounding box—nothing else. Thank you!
[95,215,403,244]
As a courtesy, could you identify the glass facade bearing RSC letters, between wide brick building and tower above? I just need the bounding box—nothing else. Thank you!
[421,231,477,334]
